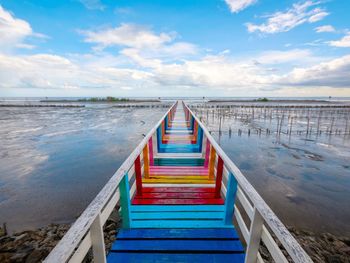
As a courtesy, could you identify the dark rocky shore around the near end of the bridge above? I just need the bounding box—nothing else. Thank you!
[0,220,350,263]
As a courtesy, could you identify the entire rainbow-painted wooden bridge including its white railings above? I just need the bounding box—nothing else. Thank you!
[45,102,312,263]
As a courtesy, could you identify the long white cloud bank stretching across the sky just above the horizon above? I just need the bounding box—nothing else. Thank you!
[0,48,350,96]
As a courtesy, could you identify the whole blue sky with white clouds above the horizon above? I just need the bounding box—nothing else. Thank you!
[0,0,350,97]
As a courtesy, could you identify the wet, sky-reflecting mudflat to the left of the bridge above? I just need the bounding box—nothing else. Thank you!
[0,107,166,233]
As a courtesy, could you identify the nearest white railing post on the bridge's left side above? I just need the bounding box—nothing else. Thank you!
[90,214,106,263]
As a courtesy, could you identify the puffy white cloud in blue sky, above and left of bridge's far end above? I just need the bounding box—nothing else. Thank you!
[80,24,198,68]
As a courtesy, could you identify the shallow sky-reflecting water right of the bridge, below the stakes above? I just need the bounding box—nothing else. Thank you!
[195,105,350,235]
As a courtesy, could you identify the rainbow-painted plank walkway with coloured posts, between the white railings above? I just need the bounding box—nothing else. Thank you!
[107,103,244,263]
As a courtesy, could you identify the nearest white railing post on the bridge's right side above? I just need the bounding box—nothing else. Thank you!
[245,208,264,263]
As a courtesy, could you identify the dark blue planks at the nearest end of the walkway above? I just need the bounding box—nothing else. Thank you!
[107,228,245,263]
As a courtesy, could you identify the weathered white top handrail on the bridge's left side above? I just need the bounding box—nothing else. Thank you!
[44,102,176,263]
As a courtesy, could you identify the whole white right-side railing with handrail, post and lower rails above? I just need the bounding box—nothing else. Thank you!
[186,103,313,263]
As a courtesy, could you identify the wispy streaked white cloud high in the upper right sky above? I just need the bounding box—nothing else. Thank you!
[246,1,329,34]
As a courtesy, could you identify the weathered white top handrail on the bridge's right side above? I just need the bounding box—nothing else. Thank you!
[184,103,313,263]
